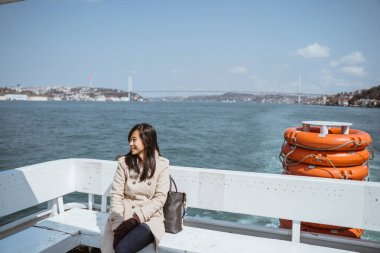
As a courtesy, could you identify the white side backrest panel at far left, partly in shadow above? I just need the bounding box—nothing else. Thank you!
[0,159,75,217]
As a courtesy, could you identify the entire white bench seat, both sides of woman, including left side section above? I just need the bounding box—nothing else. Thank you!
[0,208,352,253]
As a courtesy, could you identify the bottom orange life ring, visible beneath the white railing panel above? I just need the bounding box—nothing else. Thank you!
[280,219,364,238]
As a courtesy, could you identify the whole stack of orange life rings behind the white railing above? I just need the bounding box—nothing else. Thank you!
[280,121,373,238]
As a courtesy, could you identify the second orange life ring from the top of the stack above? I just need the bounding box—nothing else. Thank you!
[282,143,370,167]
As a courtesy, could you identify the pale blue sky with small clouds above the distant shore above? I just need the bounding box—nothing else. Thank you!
[0,0,380,96]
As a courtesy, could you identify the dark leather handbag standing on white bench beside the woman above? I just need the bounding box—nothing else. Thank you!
[163,176,186,234]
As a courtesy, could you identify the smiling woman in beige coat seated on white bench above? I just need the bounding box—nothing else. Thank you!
[102,123,169,253]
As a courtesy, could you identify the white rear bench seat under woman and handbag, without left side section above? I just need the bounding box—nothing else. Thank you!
[31,209,358,253]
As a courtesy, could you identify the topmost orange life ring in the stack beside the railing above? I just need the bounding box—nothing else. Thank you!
[284,127,372,150]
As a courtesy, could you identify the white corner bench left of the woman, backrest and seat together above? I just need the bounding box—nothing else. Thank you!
[0,159,116,253]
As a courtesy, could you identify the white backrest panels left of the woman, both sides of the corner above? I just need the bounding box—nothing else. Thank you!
[0,159,116,217]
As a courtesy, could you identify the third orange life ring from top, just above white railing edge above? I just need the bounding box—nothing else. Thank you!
[285,163,368,180]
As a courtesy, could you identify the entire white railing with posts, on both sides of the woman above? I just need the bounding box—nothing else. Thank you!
[0,159,380,252]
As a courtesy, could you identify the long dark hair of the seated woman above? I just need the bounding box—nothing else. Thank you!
[125,123,160,181]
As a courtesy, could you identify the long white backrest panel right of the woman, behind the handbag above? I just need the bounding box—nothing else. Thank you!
[171,166,380,231]
